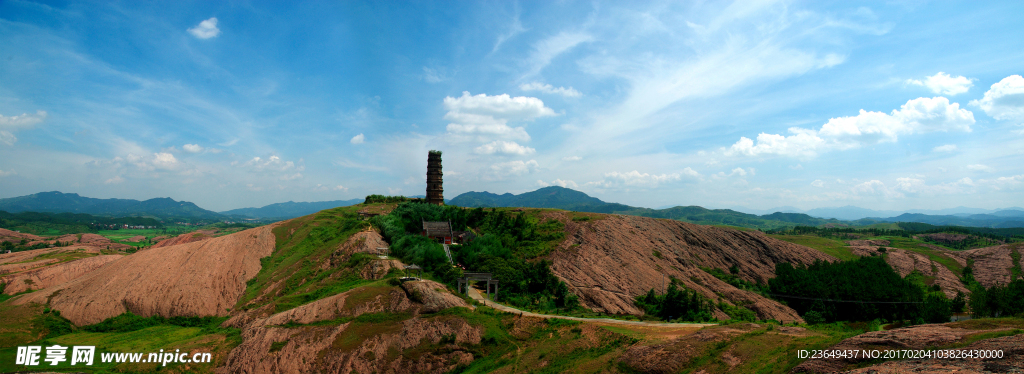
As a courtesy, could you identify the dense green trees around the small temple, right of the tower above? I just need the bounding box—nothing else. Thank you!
[371,203,579,309]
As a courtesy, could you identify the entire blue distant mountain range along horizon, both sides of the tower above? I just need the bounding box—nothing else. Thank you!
[0,186,1024,230]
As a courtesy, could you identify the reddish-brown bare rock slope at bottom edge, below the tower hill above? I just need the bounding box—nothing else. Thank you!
[218,281,481,373]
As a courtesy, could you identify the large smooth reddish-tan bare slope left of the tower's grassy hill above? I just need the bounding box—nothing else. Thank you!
[11,225,275,325]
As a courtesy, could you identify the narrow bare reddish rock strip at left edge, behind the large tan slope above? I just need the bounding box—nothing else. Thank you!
[0,254,124,295]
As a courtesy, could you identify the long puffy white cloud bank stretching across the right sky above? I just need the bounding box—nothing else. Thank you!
[725,97,975,159]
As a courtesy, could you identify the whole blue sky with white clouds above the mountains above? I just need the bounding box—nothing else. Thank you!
[0,0,1024,211]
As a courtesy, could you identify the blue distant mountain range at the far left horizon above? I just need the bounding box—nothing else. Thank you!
[0,191,224,219]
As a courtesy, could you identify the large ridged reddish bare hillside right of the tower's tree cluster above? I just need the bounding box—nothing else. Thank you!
[545,212,837,321]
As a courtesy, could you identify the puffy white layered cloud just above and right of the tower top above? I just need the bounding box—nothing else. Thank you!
[444,91,556,140]
